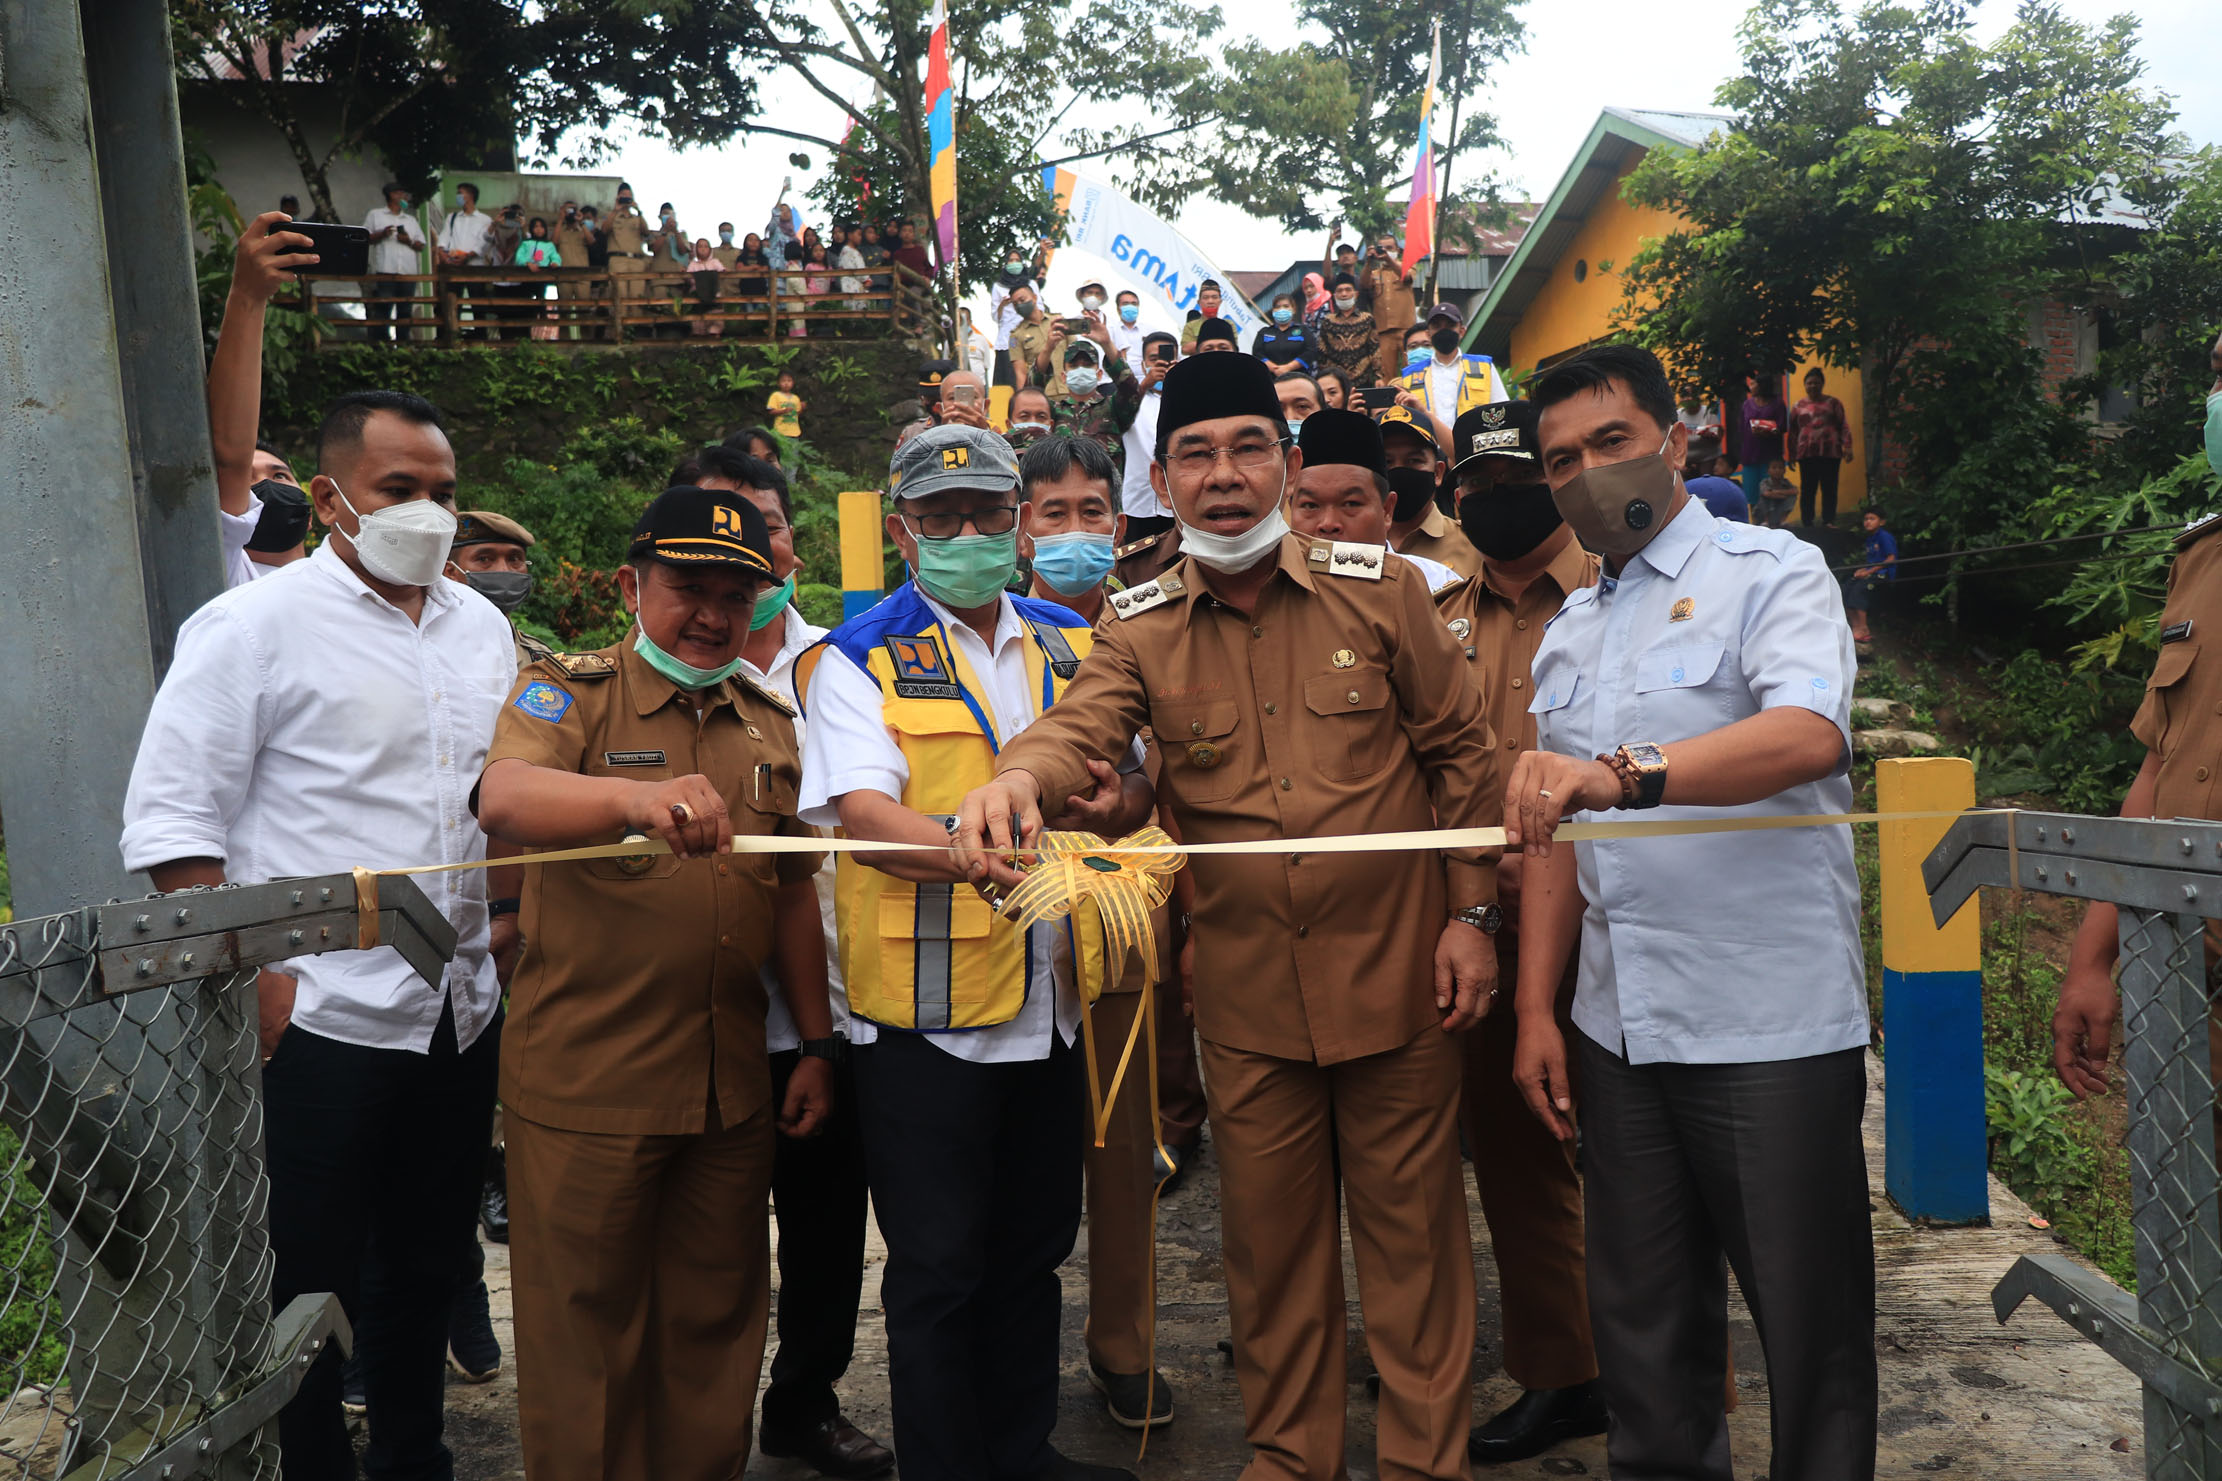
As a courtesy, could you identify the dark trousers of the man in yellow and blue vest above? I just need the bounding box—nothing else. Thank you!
[855,1030,1080,1481]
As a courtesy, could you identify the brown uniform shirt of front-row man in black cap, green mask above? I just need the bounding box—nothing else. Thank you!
[487,644,822,1135]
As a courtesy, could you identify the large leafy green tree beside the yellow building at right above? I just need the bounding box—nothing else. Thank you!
[1624,0,2180,537]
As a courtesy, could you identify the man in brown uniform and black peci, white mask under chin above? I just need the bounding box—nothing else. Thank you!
[958,355,1500,1481]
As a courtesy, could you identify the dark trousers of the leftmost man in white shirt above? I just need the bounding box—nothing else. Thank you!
[262,1012,502,1481]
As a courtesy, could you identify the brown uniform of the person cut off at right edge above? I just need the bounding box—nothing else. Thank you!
[2129,517,2222,1157]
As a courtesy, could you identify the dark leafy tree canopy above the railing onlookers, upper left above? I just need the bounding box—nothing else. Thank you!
[171,0,791,220]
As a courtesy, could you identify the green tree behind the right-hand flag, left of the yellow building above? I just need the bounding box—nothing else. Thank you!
[1190,0,1524,235]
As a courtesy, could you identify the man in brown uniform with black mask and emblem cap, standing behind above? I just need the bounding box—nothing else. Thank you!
[1438,402,1604,1463]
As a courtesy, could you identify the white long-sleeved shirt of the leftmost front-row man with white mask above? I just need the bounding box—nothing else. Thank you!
[122,544,518,1052]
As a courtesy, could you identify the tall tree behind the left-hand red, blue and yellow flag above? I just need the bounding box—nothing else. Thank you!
[751,0,1220,286]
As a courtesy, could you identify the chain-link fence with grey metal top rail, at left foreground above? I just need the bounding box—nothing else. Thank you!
[0,875,456,1481]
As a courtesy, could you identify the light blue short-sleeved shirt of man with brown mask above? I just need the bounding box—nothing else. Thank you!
[1529,500,1866,1064]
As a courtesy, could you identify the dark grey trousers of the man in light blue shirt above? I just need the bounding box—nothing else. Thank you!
[1573,1032,1875,1481]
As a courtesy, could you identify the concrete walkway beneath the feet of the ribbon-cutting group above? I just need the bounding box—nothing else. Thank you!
[449,1059,2144,1481]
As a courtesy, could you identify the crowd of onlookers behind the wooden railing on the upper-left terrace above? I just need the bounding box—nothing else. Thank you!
[328,180,938,340]
